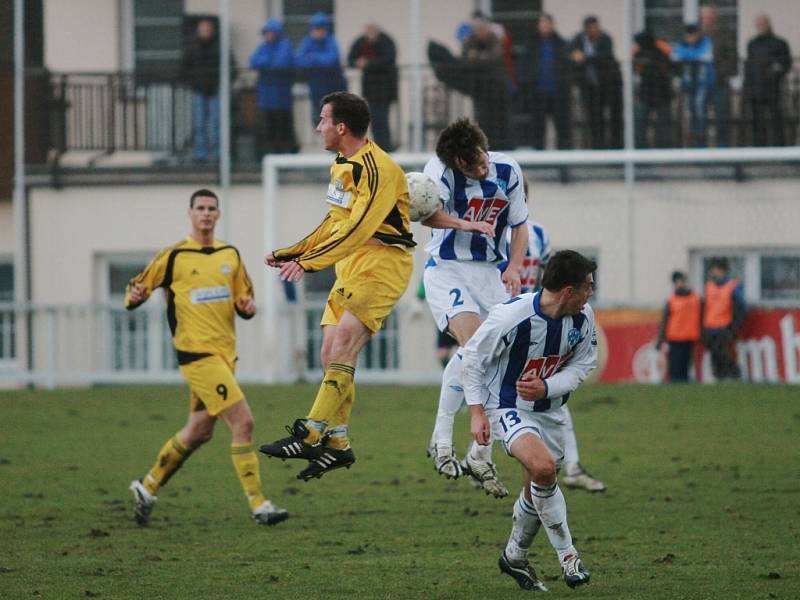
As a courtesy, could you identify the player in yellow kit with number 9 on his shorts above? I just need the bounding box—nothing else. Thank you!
[130,190,289,525]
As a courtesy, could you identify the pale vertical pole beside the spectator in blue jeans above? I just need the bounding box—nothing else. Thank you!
[219,0,232,242]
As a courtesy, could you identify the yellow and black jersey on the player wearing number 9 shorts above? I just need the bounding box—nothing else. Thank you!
[125,236,254,364]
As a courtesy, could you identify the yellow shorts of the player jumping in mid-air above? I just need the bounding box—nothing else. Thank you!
[321,245,414,333]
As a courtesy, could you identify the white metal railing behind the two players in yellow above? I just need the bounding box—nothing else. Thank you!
[0,301,418,388]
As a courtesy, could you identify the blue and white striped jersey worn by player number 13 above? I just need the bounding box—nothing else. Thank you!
[462,293,597,412]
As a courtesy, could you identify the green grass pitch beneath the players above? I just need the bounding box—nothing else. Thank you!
[0,385,800,600]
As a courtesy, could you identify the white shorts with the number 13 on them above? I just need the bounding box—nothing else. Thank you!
[487,406,567,468]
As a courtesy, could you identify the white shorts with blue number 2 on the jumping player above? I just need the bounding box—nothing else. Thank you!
[423,257,509,331]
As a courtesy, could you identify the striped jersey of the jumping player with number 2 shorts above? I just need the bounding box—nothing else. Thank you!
[425,152,528,262]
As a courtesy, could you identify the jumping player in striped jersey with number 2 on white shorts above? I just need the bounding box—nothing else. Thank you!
[416,119,528,497]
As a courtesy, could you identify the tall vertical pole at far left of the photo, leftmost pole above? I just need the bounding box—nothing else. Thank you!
[14,0,30,368]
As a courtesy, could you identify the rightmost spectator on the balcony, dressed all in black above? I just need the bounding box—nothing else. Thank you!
[744,14,792,146]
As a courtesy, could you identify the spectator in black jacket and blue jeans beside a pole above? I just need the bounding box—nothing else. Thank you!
[182,19,220,162]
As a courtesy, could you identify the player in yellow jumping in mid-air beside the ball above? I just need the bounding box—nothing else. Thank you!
[260,92,415,481]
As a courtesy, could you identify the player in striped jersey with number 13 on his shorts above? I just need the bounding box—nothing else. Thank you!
[463,250,597,589]
